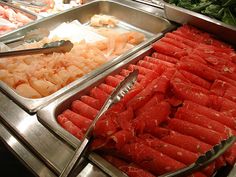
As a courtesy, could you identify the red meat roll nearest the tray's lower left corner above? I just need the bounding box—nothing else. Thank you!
[57,114,84,140]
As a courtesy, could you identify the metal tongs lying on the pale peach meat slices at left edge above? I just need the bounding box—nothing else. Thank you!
[0,40,73,58]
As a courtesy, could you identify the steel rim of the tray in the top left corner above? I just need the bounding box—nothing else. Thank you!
[0,1,38,34]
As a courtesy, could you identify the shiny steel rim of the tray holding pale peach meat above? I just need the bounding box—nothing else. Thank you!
[0,0,173,113]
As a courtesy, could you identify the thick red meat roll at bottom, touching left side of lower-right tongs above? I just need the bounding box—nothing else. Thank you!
[118,143,184,175]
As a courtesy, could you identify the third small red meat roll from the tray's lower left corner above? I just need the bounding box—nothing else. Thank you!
[71,100,98,119]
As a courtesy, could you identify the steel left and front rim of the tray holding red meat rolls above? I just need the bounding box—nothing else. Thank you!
[37,46,153,176]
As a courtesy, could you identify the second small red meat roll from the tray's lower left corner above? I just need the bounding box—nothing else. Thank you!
[62,109,92,132]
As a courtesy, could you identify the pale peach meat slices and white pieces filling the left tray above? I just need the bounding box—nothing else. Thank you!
[0,15,145,98]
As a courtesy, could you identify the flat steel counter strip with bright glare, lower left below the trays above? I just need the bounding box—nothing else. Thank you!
[0,92,73,174]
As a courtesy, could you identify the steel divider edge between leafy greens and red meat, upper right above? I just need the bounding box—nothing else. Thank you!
[164,0,236,45]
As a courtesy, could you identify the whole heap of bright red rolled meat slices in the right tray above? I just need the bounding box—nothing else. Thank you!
[39,25,236,176]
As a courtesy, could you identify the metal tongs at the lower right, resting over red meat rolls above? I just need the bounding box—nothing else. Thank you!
[159,136,236,177]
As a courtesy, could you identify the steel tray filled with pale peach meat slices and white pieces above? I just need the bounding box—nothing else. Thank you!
[0,1,171,112]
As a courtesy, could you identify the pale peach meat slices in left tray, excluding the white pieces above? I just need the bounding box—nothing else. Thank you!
[0,28,144,98]
